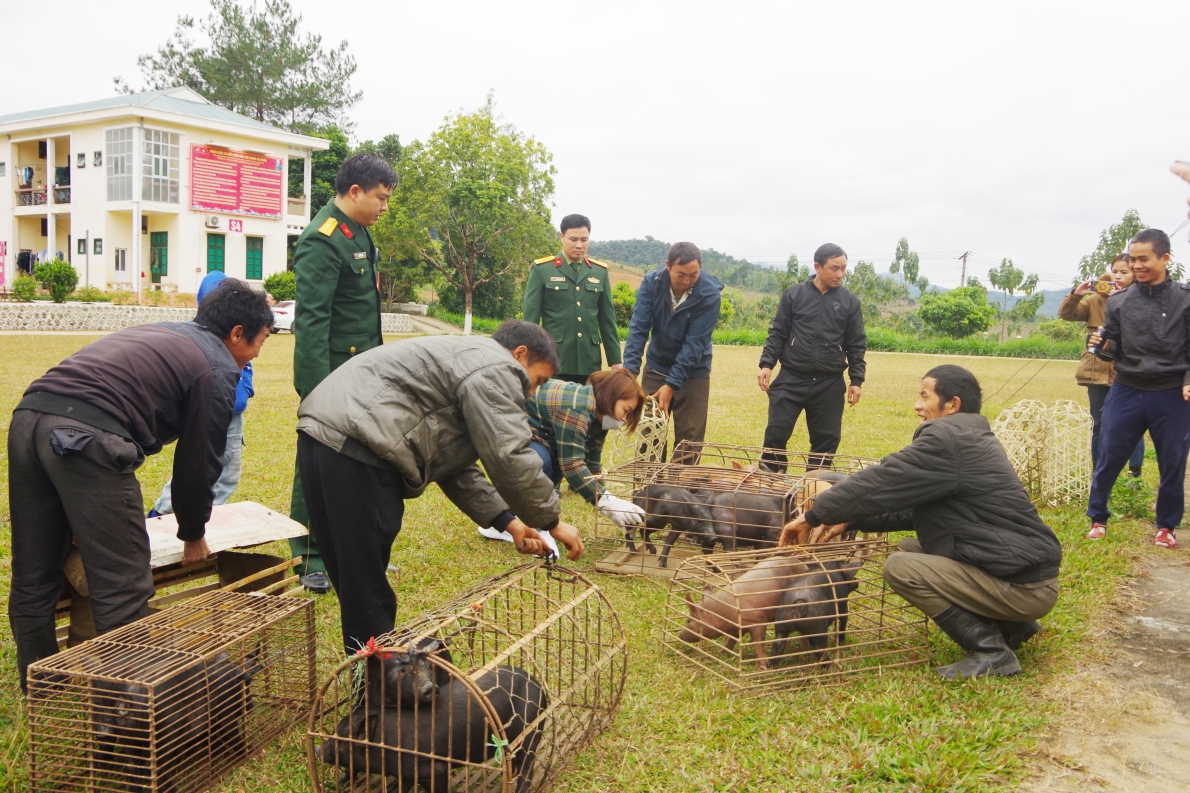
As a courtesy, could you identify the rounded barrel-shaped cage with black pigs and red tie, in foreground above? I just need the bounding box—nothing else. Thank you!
[307,563,627,793]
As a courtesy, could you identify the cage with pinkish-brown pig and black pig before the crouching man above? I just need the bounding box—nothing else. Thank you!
[664,539,928,692]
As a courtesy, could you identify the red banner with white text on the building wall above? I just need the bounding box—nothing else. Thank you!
[190,144,284,218]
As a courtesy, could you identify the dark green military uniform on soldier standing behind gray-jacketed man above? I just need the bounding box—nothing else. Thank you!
[289,199,383,575]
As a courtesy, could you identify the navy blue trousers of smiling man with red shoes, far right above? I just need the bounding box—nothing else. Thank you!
[1086,382,1190,530]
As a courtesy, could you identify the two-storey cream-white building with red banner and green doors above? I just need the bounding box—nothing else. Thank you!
[0,88,330,293]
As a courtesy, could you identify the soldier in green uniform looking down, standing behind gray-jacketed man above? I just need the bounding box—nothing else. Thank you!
[289,155,397,585]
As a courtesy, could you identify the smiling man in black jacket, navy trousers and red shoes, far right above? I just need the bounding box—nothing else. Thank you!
[1086,229,1190,548]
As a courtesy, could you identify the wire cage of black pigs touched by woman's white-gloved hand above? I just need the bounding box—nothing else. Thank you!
[591,442,878,577]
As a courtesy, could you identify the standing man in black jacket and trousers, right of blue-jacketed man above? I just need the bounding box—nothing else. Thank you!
[758,243,868,470]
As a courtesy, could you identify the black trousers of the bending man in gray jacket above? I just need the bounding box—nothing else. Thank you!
[298,432,405,655]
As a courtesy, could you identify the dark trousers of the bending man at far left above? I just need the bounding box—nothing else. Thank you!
[8,411,155,689]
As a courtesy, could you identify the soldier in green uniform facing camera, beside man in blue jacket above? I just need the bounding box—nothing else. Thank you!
[524,214,621,383]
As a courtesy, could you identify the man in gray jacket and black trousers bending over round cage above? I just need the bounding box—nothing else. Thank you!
[298,319,583,654]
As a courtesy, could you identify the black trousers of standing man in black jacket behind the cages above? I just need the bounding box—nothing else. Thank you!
[762,368,847,472]
